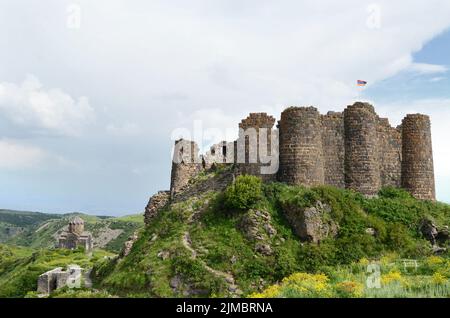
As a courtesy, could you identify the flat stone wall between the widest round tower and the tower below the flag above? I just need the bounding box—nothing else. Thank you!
[322,112,345,188]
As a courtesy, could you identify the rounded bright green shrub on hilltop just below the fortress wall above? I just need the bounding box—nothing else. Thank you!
[224,175,262,210]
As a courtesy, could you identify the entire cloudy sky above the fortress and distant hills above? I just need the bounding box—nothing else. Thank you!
[0,0,450,215]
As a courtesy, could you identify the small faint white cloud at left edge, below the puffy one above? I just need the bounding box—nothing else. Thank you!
[0,139,48,169]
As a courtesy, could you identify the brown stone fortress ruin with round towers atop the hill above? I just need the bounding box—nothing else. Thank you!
[145,102,435,224]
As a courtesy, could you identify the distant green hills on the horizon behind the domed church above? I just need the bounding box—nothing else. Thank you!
[0,209,144,253]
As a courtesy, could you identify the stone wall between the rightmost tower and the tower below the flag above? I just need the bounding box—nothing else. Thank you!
[377,118,402,187]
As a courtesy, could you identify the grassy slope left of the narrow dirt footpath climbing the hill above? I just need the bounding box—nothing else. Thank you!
[94,194,229,297]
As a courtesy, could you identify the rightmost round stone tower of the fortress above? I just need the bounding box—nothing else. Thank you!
[401,114,436,200]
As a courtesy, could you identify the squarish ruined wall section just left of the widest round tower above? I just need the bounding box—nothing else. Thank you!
[236,113,276,181]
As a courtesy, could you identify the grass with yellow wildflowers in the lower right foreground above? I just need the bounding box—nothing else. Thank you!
[251,255,450,298]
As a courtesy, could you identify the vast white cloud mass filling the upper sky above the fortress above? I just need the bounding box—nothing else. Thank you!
[0,0,450,130]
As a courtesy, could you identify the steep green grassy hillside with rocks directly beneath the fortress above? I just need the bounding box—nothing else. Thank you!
[94,178,450,297]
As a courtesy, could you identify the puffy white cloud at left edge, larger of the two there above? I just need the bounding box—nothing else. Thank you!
[0,75,94,135]
